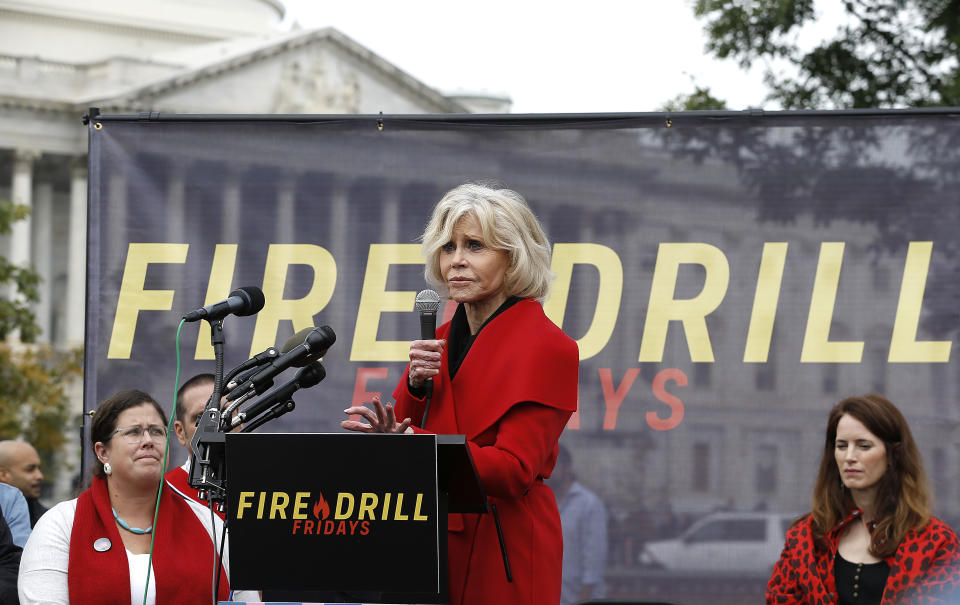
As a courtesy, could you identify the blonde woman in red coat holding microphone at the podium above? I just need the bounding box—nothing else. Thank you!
[343,184,579,605]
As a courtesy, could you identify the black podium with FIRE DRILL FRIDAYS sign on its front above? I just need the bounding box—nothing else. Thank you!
[225,433,487,603]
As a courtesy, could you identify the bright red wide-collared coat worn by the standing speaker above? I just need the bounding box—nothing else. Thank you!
[393,299,579,605]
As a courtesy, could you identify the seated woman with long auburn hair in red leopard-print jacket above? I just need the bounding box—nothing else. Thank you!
[767,394,960,605]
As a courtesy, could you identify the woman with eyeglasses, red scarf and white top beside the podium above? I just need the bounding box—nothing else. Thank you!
[18,390,258,605]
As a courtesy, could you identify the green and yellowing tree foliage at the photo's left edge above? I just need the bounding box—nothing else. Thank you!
[0,200,83,478]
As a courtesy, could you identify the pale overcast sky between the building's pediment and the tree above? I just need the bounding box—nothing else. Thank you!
[283,0,840,113]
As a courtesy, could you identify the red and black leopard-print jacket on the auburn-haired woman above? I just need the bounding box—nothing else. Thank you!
[767,509,960,605]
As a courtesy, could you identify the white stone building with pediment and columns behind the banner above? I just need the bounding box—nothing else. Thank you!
[0,0,510,494]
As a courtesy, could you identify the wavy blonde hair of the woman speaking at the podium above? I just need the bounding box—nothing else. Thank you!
[421,183,554,302]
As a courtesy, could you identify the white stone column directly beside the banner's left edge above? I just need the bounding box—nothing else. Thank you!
[63,157,87,347]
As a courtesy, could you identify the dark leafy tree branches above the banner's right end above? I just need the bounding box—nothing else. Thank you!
[694,0,960,109]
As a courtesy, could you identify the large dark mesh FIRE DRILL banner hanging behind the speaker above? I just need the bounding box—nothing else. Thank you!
[85,111,960,601]
